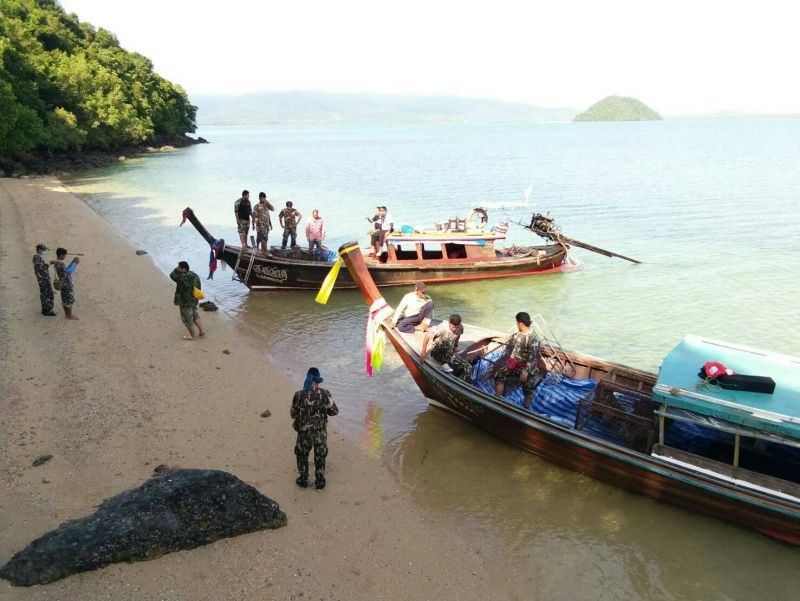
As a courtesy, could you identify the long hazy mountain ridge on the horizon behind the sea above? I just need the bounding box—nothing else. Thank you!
[192,90,577,125]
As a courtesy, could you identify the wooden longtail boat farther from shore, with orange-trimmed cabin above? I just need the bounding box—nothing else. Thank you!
[183,208,569,290]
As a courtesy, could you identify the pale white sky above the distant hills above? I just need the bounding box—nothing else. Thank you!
[61,0,800,115]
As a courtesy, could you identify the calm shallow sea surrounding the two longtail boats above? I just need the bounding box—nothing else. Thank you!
[68,119,800,600]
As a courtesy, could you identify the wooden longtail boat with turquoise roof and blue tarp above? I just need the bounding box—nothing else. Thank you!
[340,244,800,544]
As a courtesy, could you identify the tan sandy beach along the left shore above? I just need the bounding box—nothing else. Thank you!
[0,178,510,600]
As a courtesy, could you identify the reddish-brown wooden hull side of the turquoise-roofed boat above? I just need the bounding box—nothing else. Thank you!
[387,330,800,544]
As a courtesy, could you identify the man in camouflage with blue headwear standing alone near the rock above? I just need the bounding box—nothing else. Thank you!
[290,367,339,490]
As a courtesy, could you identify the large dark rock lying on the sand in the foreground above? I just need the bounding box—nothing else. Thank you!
[0,470,286,586]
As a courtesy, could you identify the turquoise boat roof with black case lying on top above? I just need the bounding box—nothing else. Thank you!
[653,336,800,439]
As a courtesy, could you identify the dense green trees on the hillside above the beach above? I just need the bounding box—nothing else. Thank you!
[0,0,197,157]
